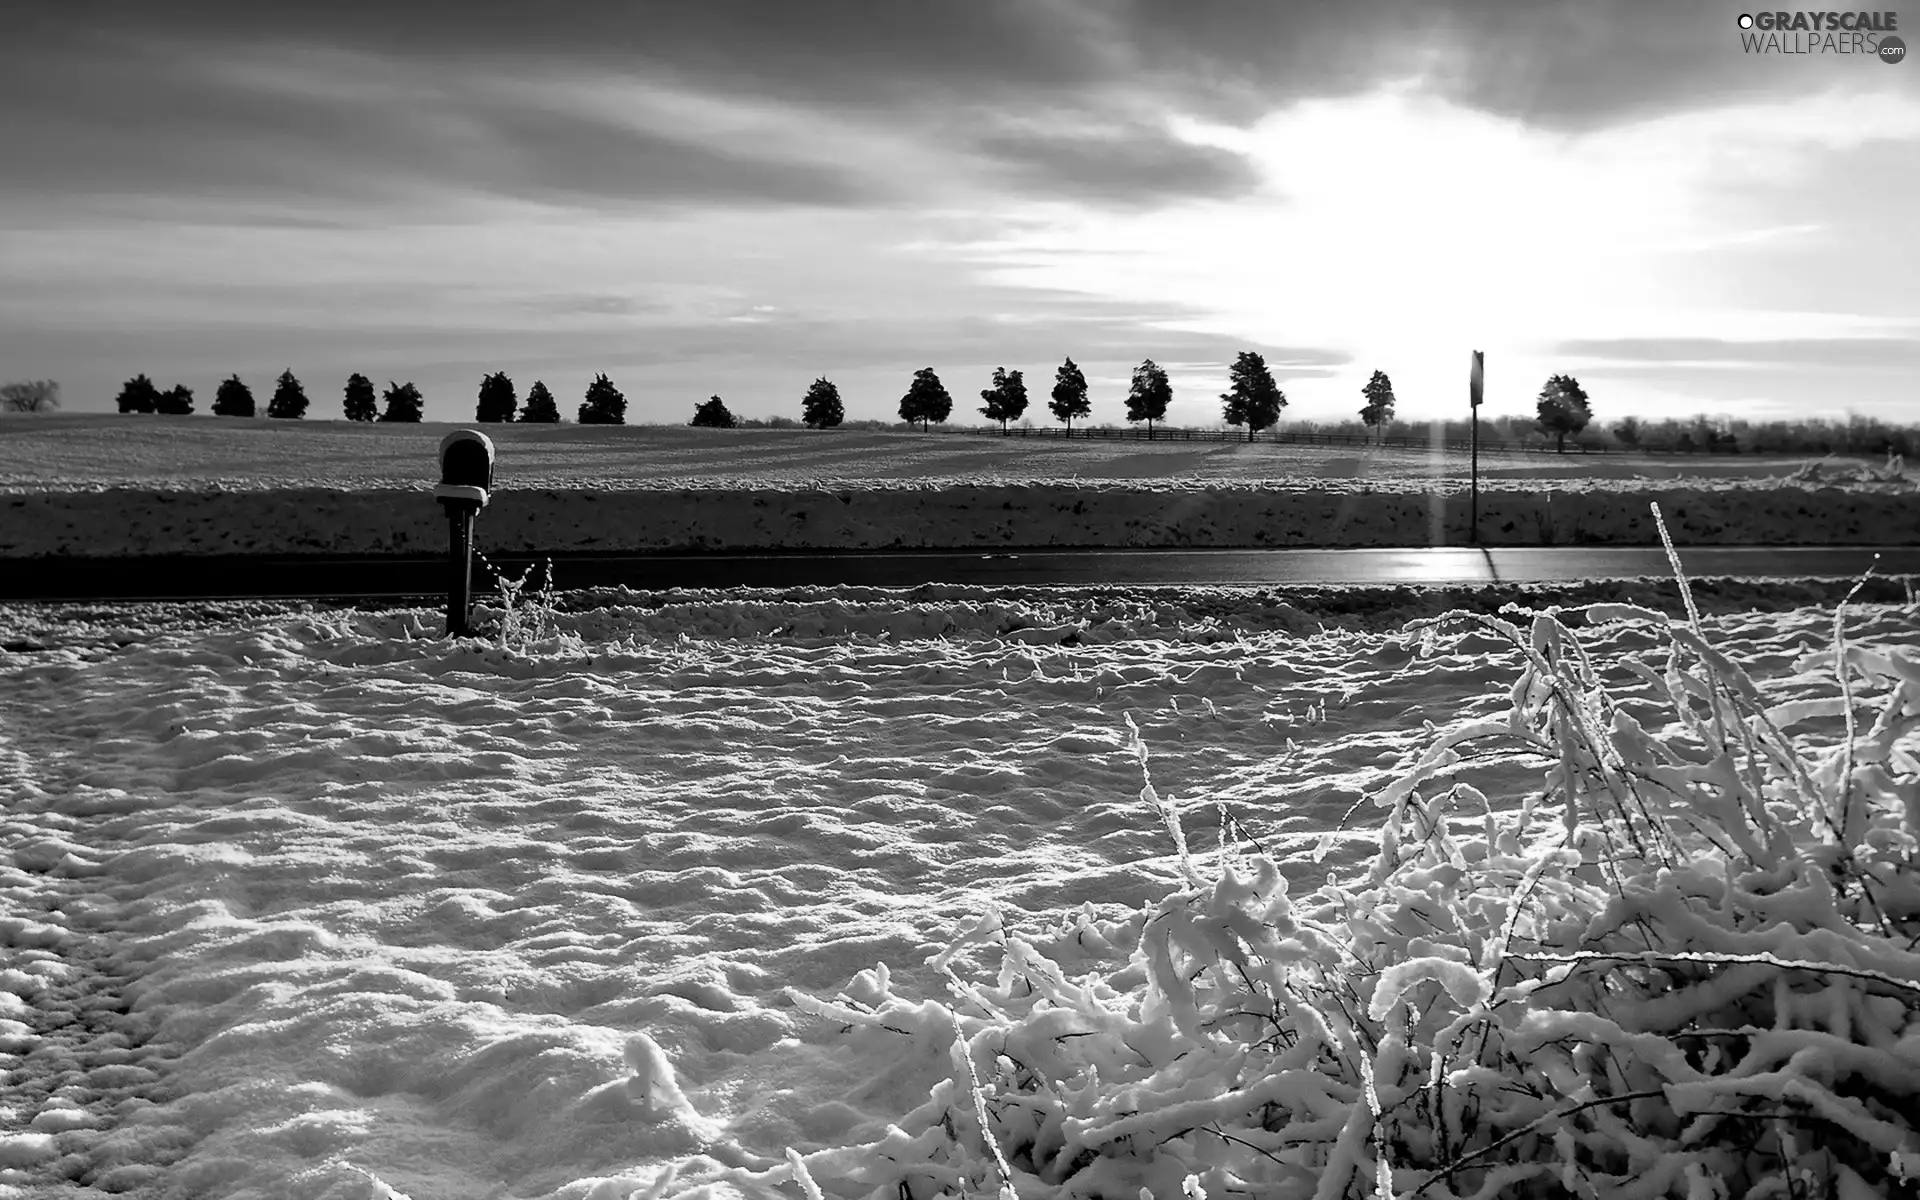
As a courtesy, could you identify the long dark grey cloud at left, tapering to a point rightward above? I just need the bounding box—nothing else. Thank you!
[0,26,885,205]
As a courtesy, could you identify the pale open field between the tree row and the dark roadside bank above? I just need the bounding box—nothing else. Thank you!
[0,413,1866,490]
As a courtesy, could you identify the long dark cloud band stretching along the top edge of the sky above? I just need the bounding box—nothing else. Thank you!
[19,0,1797,127]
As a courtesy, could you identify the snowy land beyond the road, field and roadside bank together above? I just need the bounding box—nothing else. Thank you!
[0,415,1920,557]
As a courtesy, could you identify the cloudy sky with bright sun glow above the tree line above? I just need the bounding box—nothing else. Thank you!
[0,0,1920,426]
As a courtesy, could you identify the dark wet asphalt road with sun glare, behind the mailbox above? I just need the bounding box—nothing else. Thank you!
[0,547,1920,601]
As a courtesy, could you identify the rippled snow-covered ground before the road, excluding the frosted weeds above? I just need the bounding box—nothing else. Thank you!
[0,584,1920,1200]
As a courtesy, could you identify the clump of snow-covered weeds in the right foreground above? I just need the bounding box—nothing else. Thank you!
[760,506,1920,1200]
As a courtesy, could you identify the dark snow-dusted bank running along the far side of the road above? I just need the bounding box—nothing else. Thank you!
[0,480,1920,557]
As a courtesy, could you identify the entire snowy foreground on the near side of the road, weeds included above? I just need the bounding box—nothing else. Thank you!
[0,564,1920,1200]
